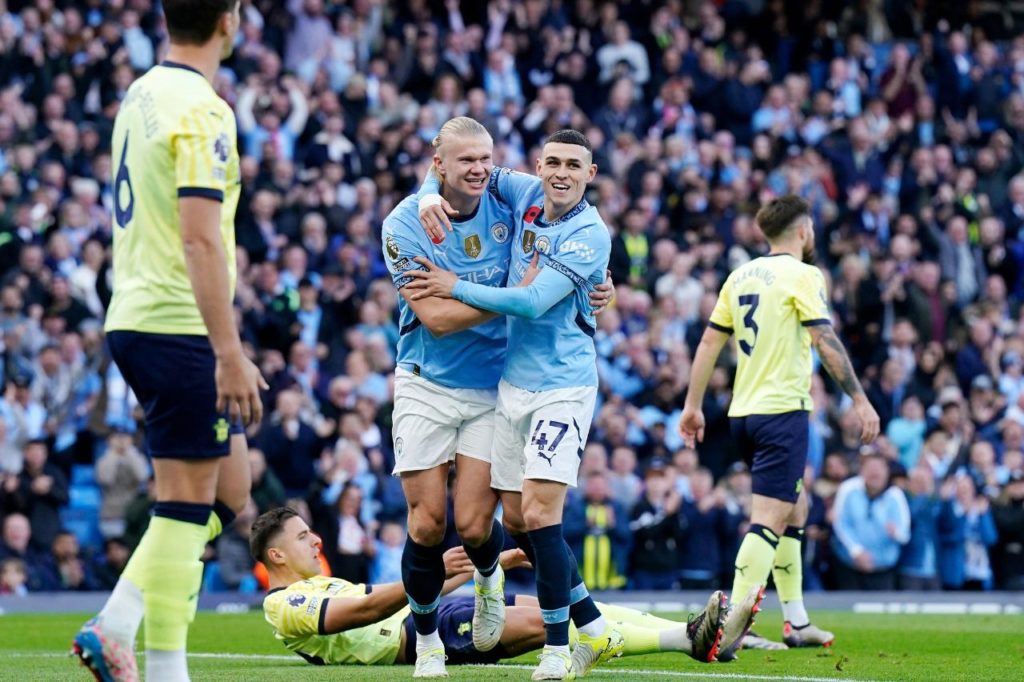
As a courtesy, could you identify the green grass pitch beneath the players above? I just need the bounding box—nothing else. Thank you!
[0,611,1024,682]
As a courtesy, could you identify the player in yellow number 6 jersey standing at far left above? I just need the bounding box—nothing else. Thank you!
[73,0,268,682]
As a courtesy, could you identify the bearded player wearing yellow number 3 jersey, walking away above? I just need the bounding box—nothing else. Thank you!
[679,195,879,660]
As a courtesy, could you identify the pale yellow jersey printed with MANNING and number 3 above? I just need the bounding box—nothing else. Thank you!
[710,254,831,417]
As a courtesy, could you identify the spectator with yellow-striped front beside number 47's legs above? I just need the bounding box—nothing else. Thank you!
[562,472,630,590]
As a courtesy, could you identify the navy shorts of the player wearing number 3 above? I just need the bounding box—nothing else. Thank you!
[729,410,810,502]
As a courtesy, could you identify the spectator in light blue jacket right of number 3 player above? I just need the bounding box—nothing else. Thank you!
[833,455,910,590]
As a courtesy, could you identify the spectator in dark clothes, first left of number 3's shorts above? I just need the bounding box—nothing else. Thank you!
[628,458,685,590]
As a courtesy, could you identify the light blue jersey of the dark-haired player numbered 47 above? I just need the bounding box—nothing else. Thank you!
[440,168,611,391]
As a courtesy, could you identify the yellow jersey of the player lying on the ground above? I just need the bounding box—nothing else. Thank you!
[263,576,410,666]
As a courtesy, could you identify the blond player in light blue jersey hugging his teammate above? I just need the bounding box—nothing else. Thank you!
[383,117,611,677]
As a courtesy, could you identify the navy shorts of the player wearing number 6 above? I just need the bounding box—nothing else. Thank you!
[106,331,244,460]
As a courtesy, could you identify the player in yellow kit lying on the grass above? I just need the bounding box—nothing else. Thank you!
[250,507,760,666]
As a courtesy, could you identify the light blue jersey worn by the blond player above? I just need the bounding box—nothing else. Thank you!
[382,193,513,388]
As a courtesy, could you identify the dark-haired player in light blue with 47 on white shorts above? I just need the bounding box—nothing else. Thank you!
[406,130,624,680]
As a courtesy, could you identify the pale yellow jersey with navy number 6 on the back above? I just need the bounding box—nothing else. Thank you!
[106,61,240,335]
